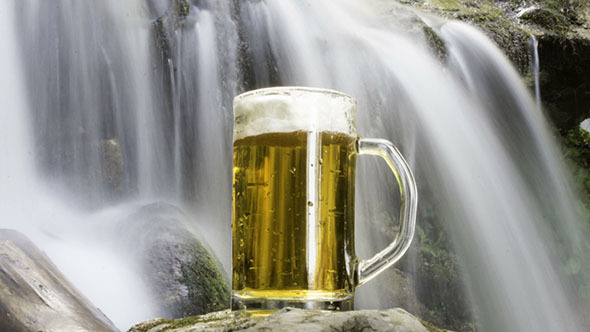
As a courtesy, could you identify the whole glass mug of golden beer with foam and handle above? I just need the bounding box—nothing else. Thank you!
[232,87,417,314]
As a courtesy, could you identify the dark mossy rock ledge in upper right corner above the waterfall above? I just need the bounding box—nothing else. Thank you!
[378,0,590,134]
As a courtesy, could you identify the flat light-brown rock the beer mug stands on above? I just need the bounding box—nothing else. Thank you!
[129,308,442,332]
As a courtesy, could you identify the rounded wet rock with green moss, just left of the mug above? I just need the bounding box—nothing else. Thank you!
[119,203,229,318]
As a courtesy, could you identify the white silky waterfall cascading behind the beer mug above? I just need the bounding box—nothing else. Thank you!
[0,0,590,331]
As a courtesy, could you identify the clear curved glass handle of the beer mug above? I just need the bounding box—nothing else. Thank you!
[356,138,418,286]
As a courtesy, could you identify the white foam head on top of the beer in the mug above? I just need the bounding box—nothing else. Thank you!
[234,87,356,141]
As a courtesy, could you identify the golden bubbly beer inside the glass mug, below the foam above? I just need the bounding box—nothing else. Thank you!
[232,131,356,299]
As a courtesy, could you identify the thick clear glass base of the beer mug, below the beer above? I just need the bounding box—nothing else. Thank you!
[232,291,354,316]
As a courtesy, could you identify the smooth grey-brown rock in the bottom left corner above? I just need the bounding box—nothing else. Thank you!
[0,229,118,332]
